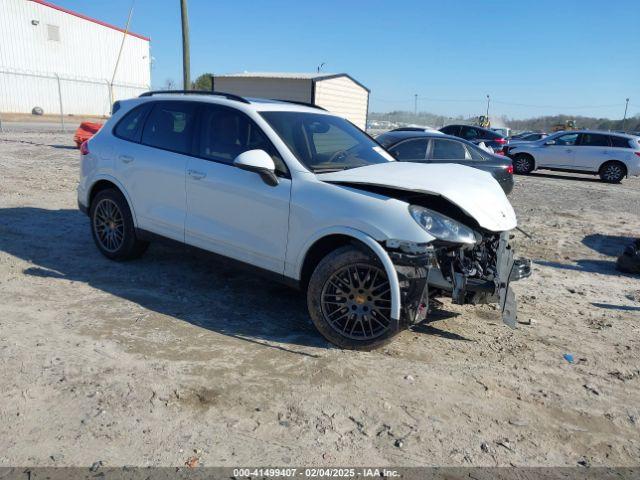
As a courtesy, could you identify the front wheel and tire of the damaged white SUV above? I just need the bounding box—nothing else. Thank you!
[307,246,398,350]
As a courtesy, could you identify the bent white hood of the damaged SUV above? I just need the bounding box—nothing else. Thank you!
[317,162,517,232]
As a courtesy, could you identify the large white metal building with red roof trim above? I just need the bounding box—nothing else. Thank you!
[0,0,151,115]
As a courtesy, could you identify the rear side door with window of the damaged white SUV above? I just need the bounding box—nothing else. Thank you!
[115,100,196,242]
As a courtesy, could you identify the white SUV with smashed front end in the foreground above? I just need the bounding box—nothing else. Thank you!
[78,92,530,349]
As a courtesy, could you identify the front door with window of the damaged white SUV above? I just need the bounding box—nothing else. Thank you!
[185,104,291,273]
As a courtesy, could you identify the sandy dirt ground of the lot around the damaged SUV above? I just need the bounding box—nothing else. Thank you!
[0,129,640,466]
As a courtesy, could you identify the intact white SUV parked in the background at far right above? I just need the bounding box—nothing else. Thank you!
[507,130,640,183]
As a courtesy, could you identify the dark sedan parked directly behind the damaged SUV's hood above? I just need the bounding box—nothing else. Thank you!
[376,131,513,194]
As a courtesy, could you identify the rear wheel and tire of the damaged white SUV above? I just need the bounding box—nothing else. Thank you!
[89,189,149,260]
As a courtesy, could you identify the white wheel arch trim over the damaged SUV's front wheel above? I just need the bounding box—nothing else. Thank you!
[293,226,402,322]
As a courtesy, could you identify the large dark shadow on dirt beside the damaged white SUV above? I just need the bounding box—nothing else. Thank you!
[0,207,462,353]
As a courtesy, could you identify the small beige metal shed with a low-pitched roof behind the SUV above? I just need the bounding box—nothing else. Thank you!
[214,72,369,130]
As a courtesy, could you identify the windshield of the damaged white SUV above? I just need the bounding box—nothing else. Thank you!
[261,112,394,173]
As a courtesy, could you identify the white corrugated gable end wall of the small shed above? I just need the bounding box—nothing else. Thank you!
[315,77,369,130]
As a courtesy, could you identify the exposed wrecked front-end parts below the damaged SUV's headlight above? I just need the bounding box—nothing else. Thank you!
[389,232,531,328]
